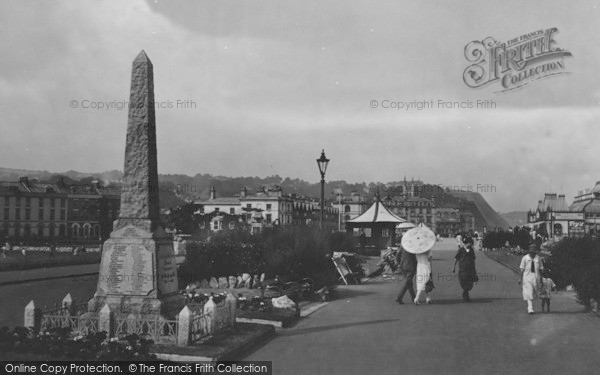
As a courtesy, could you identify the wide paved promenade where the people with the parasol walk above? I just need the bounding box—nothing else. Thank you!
[246,240,600,375]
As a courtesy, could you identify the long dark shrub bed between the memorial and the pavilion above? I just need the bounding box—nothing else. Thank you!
[179,227,340,285]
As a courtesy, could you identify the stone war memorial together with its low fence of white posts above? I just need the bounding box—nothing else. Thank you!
[24,51,246,359]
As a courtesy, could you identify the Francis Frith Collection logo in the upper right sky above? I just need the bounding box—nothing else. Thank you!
[463,27,572,92]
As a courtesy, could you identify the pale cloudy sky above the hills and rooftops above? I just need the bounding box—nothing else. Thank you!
[0,0,600,212]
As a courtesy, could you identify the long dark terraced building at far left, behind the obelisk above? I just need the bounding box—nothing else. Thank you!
[0,177,120,244]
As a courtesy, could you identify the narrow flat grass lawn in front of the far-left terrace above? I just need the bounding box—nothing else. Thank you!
[0,251,101,271]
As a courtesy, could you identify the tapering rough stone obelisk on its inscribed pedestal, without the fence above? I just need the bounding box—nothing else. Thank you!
[88,51,181,316]
